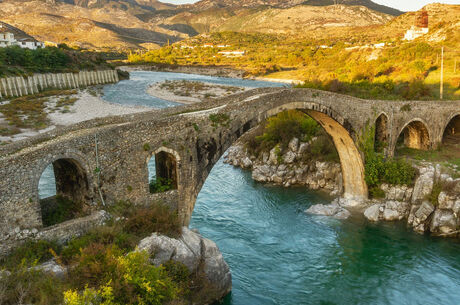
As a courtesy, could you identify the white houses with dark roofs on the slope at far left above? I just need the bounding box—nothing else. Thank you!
[0,21,45,50]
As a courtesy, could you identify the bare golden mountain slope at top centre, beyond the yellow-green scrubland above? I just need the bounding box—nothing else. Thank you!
[165,5,394,37]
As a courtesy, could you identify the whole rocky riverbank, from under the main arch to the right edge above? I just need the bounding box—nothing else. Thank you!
[224,130,460,237]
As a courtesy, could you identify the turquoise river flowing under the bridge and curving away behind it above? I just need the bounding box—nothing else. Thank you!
[40,72,460,305]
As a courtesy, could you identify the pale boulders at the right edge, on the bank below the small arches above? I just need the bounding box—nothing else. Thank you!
[364,164,460,236]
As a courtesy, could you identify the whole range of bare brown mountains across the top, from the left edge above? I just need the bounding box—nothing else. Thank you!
[0,0,402,51]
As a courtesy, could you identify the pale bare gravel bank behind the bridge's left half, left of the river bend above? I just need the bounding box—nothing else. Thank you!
[0,90,152,144]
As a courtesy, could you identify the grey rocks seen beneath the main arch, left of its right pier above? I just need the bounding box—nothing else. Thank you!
[224,138,343,196]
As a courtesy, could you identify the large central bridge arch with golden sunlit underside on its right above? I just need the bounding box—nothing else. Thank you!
[182,102,368,224]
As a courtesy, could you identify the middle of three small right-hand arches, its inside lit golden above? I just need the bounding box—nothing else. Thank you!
[397,118,431,150]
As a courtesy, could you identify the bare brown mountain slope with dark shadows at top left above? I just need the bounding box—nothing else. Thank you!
[0,1,188,50]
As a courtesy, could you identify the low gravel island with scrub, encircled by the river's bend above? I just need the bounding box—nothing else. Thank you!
[147,81,252,104]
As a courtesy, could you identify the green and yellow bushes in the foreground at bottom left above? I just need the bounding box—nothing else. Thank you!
[0,202,225,305]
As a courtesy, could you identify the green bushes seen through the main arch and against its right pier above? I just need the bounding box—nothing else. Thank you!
[234,110,416,192]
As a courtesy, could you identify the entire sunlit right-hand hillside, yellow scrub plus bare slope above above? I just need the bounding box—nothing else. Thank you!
[129,4,460,99]
